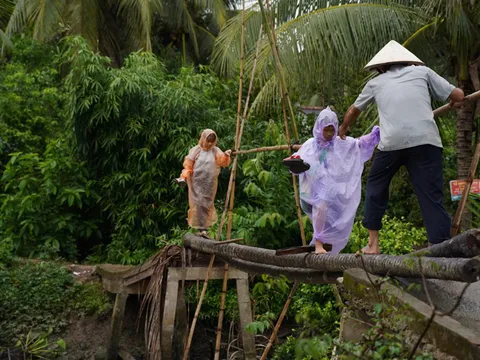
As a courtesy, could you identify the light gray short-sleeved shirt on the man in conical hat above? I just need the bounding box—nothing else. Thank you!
[354,65,455,151]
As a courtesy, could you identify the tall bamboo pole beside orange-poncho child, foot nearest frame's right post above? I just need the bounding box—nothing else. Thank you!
[214,22,262,360]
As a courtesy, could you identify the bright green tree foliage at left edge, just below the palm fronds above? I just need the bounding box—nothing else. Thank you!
[0,39,65,161]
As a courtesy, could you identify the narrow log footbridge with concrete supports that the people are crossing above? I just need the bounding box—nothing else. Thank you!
[97,230,480,360]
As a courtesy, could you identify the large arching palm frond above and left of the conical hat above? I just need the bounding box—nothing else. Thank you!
[216,1,421,109]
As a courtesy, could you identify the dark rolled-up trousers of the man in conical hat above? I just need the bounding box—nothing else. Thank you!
[363,145,451,244]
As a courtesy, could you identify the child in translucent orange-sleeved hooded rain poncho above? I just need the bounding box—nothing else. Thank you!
[176,129,232,237]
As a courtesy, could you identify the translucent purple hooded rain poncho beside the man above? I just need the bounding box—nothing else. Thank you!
[294,107,380,254]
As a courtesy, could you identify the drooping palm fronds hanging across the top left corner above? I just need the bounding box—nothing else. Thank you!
[0,0,226,64]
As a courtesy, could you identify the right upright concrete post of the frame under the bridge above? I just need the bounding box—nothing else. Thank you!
[237,273,257,360]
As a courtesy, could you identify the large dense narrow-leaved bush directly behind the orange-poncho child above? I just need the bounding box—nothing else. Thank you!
[63,38,238,264]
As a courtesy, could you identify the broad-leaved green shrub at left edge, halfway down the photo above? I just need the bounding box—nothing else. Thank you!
[0,140,101,261]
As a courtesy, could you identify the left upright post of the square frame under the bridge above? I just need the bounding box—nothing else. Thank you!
[162,269,178,360]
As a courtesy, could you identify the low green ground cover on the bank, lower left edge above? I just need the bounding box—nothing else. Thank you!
[0,263,109,345]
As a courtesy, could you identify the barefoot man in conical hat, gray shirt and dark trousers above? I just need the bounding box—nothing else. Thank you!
[339,40,464,254]
